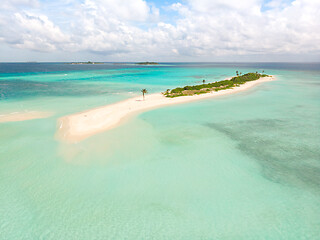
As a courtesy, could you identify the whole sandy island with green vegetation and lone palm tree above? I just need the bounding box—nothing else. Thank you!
[56,72,275,143]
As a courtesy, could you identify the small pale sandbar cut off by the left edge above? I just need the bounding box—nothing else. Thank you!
[0,111,52,123]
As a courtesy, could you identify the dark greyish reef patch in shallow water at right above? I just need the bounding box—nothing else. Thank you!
[205,119,320,193]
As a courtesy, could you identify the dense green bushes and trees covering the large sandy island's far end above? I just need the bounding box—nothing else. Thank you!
[163,71,269,98]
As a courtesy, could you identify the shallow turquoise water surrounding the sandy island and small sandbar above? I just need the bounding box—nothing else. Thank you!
[0,64,320,239]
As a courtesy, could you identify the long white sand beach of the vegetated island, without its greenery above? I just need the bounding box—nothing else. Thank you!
[56,77,274,142]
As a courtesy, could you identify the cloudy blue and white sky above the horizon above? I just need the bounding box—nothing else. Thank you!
[0,0,320,62]
